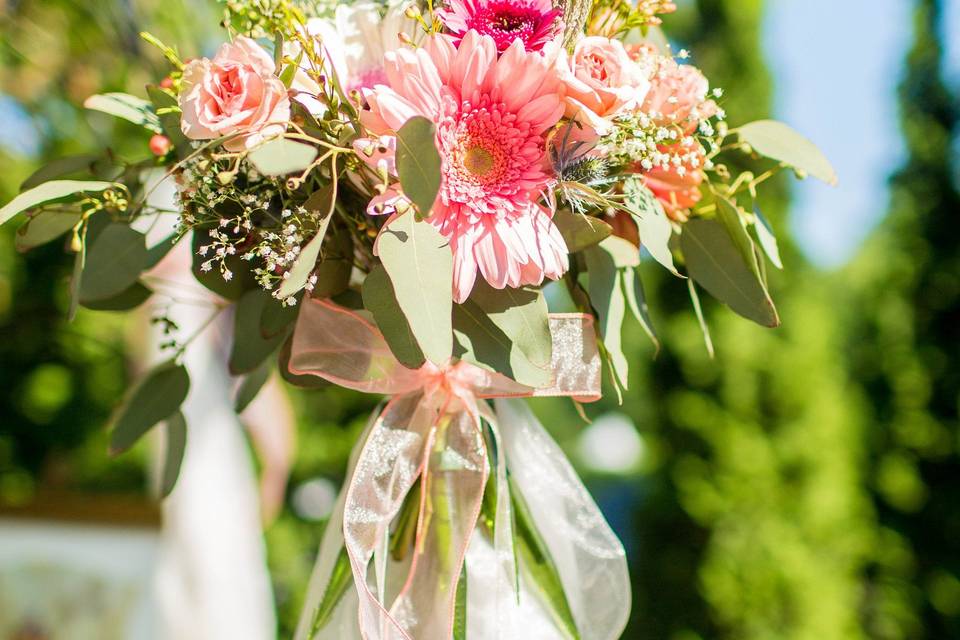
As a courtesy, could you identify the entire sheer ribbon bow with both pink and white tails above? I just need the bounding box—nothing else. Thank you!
[290,299,630,640]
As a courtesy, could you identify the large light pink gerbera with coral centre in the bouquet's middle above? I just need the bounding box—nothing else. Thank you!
[361,31,568,302]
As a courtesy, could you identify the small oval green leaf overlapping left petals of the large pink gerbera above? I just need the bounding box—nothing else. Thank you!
[397,116,440,217]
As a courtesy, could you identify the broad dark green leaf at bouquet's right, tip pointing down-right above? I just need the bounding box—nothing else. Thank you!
[680,218,780,327]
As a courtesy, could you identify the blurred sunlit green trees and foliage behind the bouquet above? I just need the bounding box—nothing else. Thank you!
[0,0,960,640]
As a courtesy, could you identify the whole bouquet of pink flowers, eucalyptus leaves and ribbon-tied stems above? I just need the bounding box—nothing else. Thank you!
[0,0,835,640]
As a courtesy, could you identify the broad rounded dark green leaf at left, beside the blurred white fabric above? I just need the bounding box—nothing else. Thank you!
[80,222,149,303]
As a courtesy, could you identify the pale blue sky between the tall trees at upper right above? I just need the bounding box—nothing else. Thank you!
[764,0,960,267]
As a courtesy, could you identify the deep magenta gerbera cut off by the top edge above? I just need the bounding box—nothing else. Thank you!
[437,0,563,51]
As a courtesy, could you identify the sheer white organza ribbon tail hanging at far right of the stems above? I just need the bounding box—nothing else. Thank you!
[496,400,631,640]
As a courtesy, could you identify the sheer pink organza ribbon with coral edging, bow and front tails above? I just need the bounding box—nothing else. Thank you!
[290,299,604,640]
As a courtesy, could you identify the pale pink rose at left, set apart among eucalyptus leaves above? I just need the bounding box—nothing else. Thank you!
[180,36,290,151]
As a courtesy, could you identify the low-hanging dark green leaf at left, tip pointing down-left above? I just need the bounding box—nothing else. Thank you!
[110,361,190,455]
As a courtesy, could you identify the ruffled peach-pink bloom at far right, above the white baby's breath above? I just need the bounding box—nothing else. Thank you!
[642,56,717,135]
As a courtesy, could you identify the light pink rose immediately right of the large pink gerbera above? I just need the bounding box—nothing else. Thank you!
[560,36,650,135]
